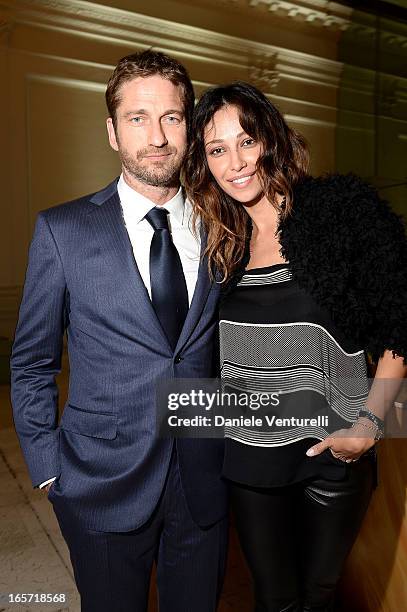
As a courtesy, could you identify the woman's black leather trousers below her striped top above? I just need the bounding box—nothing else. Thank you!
[230,455,375,612]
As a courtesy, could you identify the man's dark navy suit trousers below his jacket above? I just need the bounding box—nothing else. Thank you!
[50,445,227,612]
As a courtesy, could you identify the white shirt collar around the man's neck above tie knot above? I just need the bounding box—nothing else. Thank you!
[117,174,190,226]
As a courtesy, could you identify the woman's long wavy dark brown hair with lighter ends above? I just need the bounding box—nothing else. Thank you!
[183,81,309,281]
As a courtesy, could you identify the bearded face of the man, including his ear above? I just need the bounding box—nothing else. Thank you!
[107,75,187,187]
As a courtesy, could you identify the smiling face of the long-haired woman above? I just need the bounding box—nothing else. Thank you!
[204,106,263,204]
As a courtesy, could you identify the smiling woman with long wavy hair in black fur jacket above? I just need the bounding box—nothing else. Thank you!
[185,82,407,612]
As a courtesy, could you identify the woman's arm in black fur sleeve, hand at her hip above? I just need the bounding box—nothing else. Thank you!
[309,175,407,461]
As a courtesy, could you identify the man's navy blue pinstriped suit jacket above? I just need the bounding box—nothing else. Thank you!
[11,181,226,531]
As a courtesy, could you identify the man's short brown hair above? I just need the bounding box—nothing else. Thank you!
[106,49,195,131]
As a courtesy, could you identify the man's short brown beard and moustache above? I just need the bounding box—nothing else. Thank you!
[119,147,186,187]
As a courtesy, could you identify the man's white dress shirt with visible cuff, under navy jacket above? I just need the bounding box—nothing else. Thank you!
[39,175,201,489]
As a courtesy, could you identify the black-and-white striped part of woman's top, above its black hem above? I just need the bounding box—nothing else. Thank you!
[220,264,368,446]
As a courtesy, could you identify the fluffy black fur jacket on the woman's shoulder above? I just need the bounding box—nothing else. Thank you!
[226,174,407,362]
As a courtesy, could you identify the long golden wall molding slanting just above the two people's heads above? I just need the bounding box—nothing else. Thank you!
[0,0,342,90]
